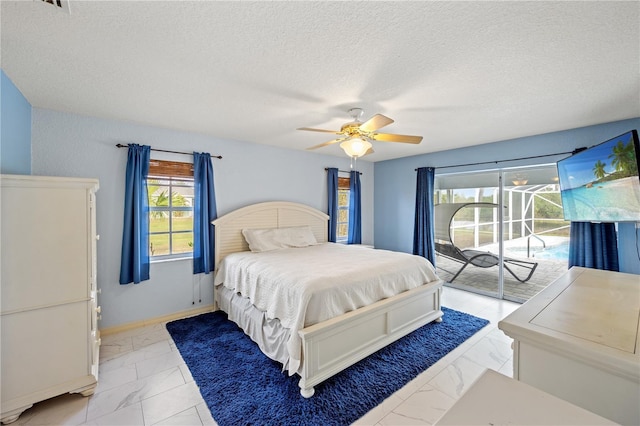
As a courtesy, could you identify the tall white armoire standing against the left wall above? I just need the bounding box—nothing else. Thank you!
[0,175,100,423]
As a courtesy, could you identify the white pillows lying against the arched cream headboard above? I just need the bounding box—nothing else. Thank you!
[242,226,318,253]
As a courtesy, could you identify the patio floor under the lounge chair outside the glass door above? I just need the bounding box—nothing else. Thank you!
[436,255,568,303]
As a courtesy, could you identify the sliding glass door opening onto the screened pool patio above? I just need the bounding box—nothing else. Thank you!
[434,164,569,303]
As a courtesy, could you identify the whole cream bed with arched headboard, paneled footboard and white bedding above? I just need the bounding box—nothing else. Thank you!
[213,201,442,398]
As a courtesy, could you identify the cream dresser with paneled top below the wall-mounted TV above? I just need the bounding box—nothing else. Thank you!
[498,267,640,425]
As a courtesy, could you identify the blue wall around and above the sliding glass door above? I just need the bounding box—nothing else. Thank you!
[374,118,640,274]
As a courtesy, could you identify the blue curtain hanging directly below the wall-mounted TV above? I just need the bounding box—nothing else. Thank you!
[569,222,619,272]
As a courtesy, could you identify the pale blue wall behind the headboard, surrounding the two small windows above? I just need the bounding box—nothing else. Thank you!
[32,108,374,328]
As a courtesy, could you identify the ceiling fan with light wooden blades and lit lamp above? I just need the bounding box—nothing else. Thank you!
[298,108,422,157]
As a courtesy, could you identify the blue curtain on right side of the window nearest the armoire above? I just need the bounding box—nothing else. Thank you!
[193,152,218,274]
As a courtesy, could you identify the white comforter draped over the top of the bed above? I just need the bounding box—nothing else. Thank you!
[215,243,438,374]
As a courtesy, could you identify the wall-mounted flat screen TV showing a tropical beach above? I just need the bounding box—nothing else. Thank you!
[557,130,640,222]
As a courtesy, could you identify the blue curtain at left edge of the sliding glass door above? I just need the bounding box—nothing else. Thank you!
[413,167,436,266]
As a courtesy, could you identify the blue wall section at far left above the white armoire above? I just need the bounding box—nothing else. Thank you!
[0,70,31,175]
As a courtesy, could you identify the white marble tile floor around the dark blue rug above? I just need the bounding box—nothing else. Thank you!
[12,287,520,426]
